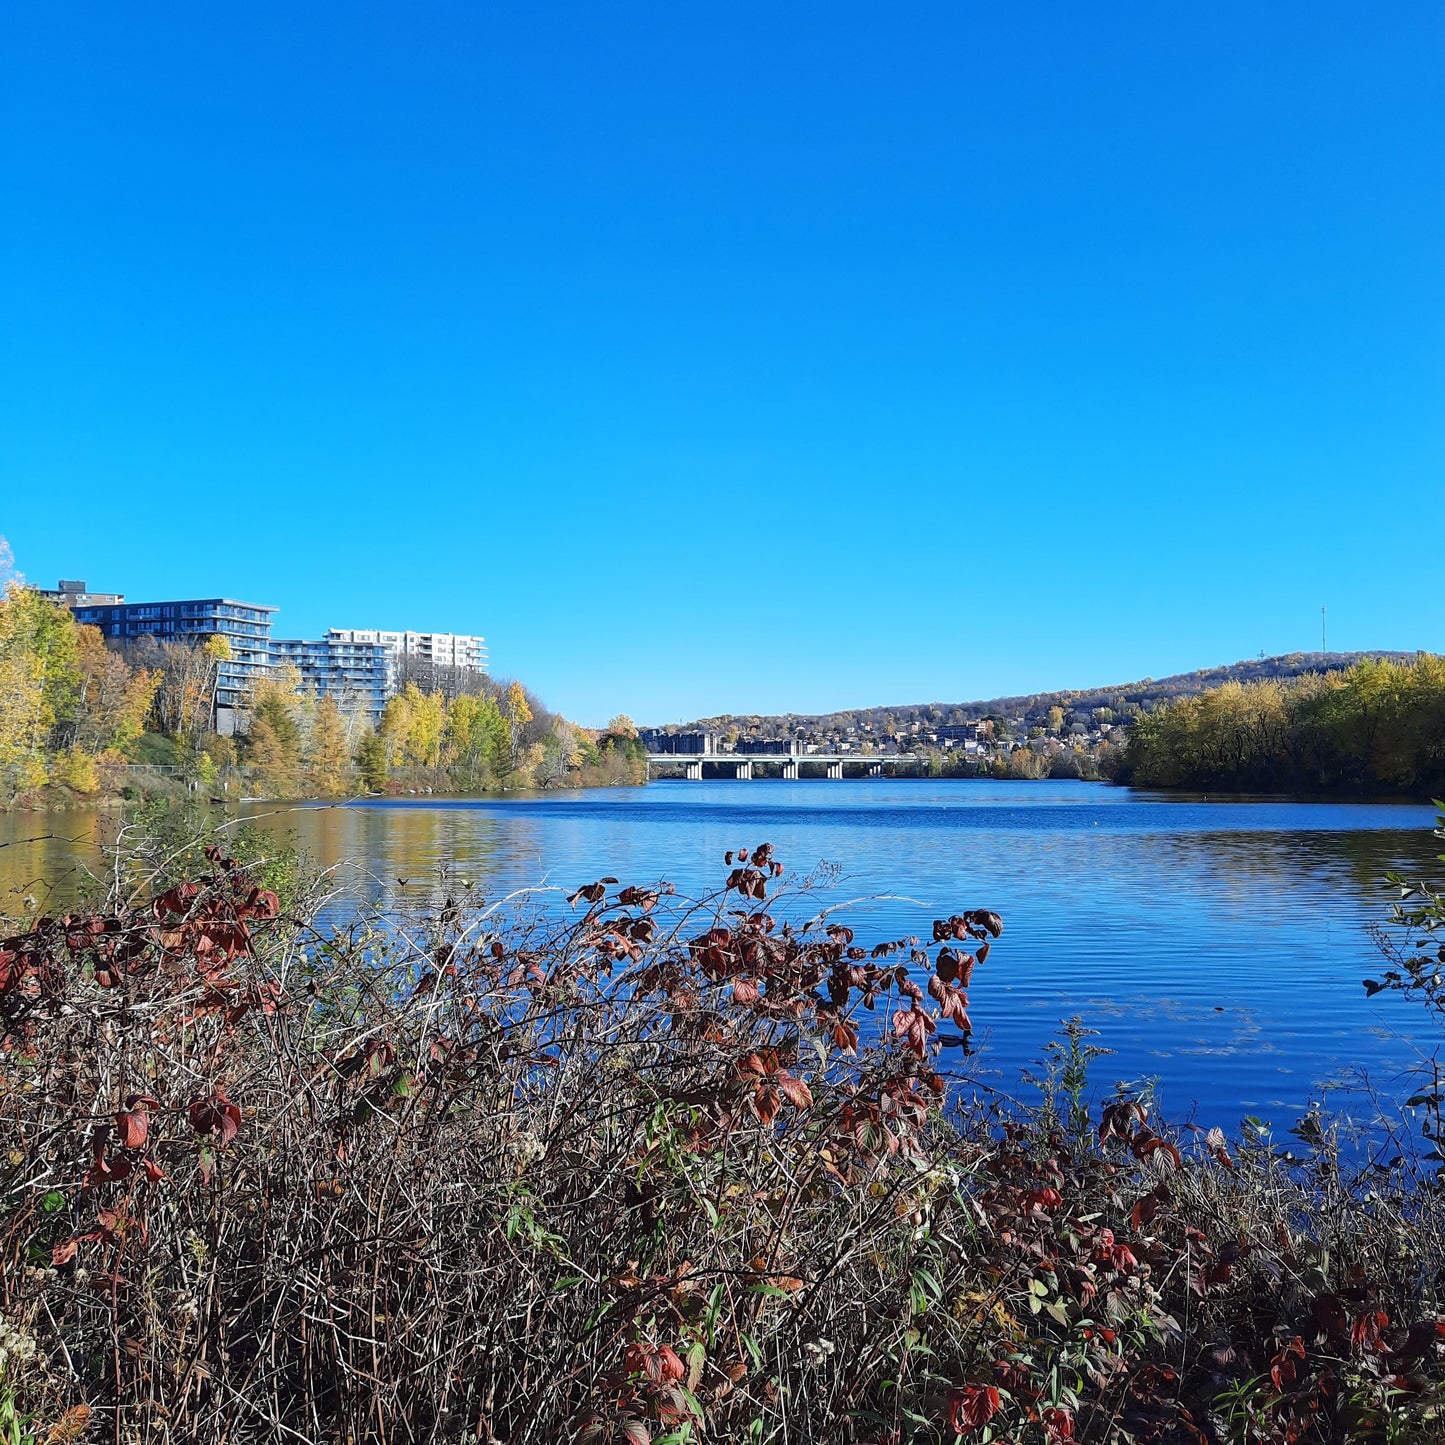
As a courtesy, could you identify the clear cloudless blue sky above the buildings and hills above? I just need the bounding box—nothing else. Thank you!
[0,0,1445,723]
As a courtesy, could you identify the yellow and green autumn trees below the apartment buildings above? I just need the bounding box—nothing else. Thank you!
[0,582,646,809]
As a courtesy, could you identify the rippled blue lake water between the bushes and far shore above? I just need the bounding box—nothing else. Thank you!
[0,779,1441,1126]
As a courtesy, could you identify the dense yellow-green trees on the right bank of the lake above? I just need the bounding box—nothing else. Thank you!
[1121,653,1445,795]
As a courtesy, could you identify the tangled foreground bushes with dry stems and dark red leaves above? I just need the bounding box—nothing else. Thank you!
[0,845,1445,1445]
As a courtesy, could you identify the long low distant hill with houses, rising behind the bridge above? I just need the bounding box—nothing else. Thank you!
[661,652,1416,737]
